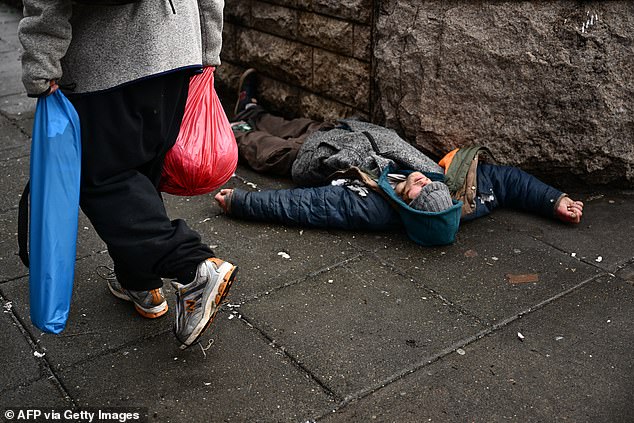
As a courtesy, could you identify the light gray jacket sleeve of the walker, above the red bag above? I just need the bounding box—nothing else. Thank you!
[198,0,225,66]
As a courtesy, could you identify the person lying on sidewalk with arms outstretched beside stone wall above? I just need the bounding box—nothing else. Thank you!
[215,71,583,245]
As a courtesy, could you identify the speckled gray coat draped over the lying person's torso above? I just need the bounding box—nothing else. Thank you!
[292,120,443,186]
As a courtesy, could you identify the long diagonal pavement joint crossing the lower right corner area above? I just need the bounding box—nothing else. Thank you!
[314,274,606,421]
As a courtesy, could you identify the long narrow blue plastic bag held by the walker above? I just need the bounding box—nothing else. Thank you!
[29,90,81,333]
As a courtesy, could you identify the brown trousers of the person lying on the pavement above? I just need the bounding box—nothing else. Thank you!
[234,106,333,176]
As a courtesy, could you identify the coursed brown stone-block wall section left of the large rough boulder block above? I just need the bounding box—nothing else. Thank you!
[218,0,373,119]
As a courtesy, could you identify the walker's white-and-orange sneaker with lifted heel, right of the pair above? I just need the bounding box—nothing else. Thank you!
[172,257,238,349]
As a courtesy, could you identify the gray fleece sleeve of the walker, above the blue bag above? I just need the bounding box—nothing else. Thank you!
[18,0,72,96]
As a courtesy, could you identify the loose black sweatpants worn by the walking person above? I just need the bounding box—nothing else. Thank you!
[68,71,213,291]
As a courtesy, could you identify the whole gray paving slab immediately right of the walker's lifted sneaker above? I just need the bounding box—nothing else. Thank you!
[240,256,484,397]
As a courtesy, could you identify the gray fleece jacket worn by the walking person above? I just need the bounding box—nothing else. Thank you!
[18,0,224,95]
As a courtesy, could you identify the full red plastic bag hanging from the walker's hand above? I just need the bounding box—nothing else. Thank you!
[160,67,238,195]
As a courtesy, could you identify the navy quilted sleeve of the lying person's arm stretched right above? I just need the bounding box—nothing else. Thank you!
[476,163,565,217]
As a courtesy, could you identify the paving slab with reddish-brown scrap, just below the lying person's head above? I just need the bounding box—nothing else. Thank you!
[376,214,600,324]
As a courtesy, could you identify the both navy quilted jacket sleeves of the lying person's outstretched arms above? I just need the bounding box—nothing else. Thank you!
[230,163,564,230]
